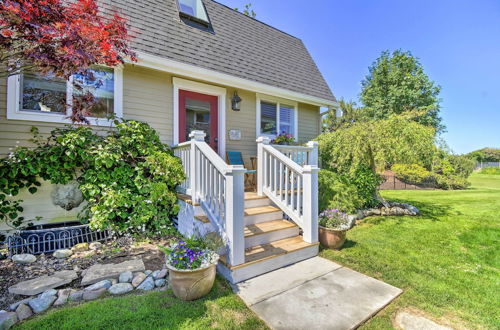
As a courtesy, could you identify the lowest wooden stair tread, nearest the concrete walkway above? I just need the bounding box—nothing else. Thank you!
[220,236,319,270]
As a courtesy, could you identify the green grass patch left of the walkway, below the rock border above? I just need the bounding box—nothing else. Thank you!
[18,278,267,330]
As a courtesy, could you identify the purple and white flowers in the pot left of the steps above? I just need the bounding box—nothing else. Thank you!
[167,241,219,270]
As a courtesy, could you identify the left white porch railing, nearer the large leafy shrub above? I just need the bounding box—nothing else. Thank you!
[174,131,246,266]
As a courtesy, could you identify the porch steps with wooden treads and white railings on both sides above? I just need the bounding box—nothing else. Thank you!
[174,131,319,283]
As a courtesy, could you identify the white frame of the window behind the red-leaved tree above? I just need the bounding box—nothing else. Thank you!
[7,67,123,126]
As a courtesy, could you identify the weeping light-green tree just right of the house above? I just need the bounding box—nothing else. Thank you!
[318,114,435,206]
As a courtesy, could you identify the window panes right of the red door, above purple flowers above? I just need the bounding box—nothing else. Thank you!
[257,100,297,138]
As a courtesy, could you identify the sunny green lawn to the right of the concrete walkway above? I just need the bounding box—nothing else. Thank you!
[321,174,500,329]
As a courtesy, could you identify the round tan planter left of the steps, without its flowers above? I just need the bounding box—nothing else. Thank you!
[167,263,216,300]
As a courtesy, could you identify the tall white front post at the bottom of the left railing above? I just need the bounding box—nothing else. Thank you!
[225,165,246,266]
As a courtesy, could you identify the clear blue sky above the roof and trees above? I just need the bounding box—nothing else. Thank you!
[218,0,500,153]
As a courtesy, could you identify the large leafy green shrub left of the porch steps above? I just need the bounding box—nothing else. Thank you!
[0,121,184,233]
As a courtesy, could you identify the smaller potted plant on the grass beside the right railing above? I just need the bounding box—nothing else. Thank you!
[318,209,351,250]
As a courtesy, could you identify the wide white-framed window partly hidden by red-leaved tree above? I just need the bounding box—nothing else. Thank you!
[7,68,122,125]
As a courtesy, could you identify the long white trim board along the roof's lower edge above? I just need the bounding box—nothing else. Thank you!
[133,52,339,107]
